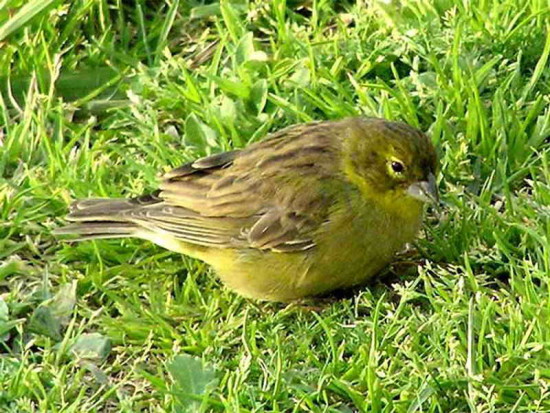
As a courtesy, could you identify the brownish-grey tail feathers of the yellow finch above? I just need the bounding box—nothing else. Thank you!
[54,197,154,241]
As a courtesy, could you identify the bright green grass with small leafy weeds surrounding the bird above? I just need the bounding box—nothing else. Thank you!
[0,0,550,413]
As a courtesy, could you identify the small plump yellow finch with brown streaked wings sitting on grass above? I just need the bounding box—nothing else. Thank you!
[56,118,437,301]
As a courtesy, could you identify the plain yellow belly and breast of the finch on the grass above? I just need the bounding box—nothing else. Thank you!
[155,198,422,301]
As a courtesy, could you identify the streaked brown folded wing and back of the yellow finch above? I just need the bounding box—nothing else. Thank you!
[126,123,339,252]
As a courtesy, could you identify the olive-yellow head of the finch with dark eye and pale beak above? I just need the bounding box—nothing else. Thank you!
[342,118,438,210]
